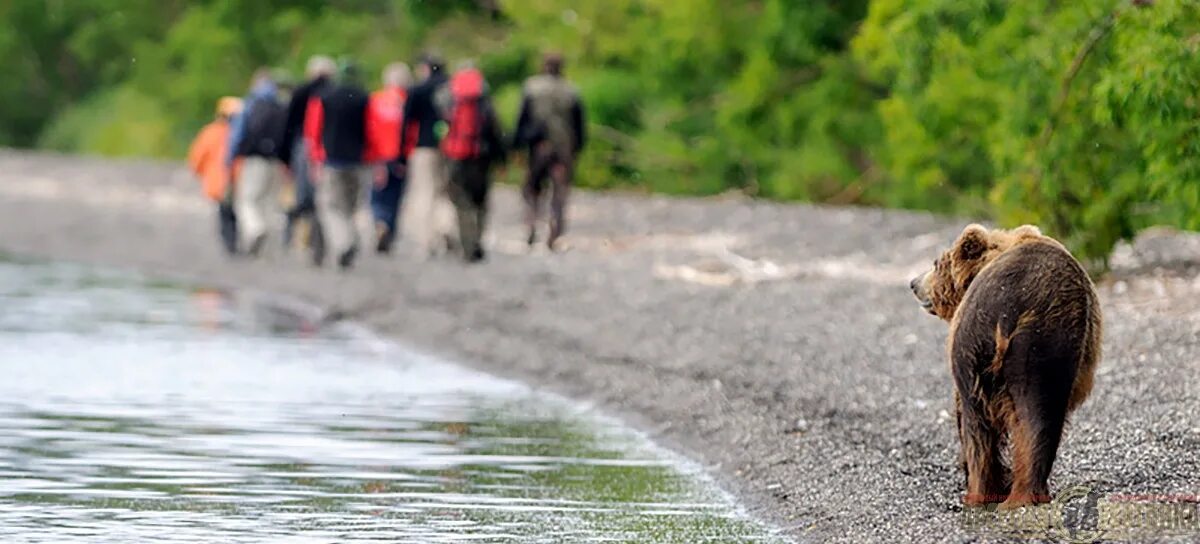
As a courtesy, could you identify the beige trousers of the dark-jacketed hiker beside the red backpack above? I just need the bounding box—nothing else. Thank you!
[400,148,458,257]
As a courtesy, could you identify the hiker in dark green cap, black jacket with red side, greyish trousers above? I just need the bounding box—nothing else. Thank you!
[305,60,371,269]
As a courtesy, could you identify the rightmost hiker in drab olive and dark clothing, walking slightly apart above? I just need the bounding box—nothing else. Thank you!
[512,53,587,251]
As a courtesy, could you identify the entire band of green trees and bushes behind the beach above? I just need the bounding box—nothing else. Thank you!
[0,0,1200,263]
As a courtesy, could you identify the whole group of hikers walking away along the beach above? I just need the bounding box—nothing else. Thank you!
[188,54,586,269]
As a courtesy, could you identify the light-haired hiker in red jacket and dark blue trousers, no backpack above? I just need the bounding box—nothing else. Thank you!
[367,62,416,253]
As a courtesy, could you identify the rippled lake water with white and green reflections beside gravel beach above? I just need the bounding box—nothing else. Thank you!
[0,261,776,543]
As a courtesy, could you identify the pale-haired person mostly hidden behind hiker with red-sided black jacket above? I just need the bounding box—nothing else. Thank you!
[281,55,337,262]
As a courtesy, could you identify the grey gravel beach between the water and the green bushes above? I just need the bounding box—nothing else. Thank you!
[0,151,1200,542]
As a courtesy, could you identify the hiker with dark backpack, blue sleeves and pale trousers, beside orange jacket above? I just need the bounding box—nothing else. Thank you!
[226,70,287,256]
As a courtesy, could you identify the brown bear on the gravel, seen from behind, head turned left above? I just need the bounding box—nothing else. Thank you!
[911,225,1100,509]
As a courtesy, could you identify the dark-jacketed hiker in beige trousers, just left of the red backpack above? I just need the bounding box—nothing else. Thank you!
[400,55,456,258]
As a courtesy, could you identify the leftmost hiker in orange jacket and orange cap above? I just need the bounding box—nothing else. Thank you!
[187,96,241,256]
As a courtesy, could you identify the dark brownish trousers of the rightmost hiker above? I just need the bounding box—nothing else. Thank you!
[521,145,575,246]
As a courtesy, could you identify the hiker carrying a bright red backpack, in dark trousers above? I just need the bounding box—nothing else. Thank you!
[438,66,505,263]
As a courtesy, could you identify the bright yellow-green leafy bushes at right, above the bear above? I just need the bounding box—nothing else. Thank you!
[854,0,1200,262]
